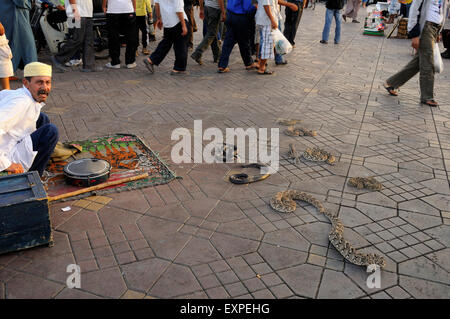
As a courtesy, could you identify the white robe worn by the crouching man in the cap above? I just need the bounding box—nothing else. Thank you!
[0,87,45,172]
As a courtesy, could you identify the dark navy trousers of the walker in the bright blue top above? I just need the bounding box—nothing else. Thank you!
[219,11,253,68]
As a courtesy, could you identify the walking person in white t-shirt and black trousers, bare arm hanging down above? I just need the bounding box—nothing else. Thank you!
[144,0,189,75]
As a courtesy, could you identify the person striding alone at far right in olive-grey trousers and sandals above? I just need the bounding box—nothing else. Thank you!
[384,0,449,107]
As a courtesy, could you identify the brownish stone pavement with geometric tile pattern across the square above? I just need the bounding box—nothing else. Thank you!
[0,4,450,298]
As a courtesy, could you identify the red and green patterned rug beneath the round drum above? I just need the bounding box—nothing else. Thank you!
[40,134,179,201]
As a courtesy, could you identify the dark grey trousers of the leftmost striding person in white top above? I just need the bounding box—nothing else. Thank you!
[55,17,95,69]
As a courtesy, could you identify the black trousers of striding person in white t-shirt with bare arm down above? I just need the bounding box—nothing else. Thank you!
[150,20,189,71]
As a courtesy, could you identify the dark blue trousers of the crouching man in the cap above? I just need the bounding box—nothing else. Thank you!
[29,112,59,176]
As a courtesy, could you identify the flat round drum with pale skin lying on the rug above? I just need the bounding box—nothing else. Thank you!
[63,158,111,187]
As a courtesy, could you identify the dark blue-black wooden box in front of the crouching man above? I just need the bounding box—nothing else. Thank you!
[0,171,53,254]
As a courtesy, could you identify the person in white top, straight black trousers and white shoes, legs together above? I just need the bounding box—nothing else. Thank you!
[103,0,137,69]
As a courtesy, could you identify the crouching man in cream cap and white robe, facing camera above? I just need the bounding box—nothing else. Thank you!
[0,62,59,176]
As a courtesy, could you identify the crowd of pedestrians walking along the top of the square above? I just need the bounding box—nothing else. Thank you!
[0,0,450,97]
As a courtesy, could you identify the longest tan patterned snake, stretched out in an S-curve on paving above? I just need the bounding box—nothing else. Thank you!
[270,190,386,268]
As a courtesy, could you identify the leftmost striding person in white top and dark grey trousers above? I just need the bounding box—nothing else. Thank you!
[51,0,102,72]
